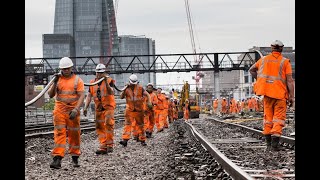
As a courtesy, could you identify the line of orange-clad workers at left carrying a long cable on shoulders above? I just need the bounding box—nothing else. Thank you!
[48,57,188,169]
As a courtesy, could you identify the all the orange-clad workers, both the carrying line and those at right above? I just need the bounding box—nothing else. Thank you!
[48,40,294,169]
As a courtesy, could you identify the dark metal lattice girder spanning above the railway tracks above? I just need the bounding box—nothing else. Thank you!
[25,52,261,75]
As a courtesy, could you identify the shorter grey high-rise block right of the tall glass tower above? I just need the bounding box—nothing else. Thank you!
[115,35,156,86]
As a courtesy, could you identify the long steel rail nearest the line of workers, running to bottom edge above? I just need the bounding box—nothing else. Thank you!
[185,122,254,180]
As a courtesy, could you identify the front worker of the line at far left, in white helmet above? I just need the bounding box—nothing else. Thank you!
[48,57,85,169]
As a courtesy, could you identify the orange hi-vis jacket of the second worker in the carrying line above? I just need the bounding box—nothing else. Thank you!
[89,78,116,110]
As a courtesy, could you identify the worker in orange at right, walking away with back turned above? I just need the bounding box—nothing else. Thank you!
[249,40,294,151]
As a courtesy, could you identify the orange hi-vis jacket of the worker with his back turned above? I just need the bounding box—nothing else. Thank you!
[254,52,292,99]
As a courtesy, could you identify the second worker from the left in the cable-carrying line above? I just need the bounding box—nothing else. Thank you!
[83,64,116,154]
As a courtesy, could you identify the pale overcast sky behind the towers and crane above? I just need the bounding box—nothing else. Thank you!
[25,0,295,90]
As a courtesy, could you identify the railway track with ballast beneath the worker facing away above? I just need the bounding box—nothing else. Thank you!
[185,118,295,179]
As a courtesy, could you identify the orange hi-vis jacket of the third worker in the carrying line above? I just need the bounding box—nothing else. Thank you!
[125,84,145,112]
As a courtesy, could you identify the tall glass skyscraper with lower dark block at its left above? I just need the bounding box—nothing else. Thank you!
[43,0,119,81]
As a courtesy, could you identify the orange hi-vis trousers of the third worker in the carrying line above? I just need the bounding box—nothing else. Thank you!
[122,110,146,141]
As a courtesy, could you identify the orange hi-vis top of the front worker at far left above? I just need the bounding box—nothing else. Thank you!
[54,74,84,113]
